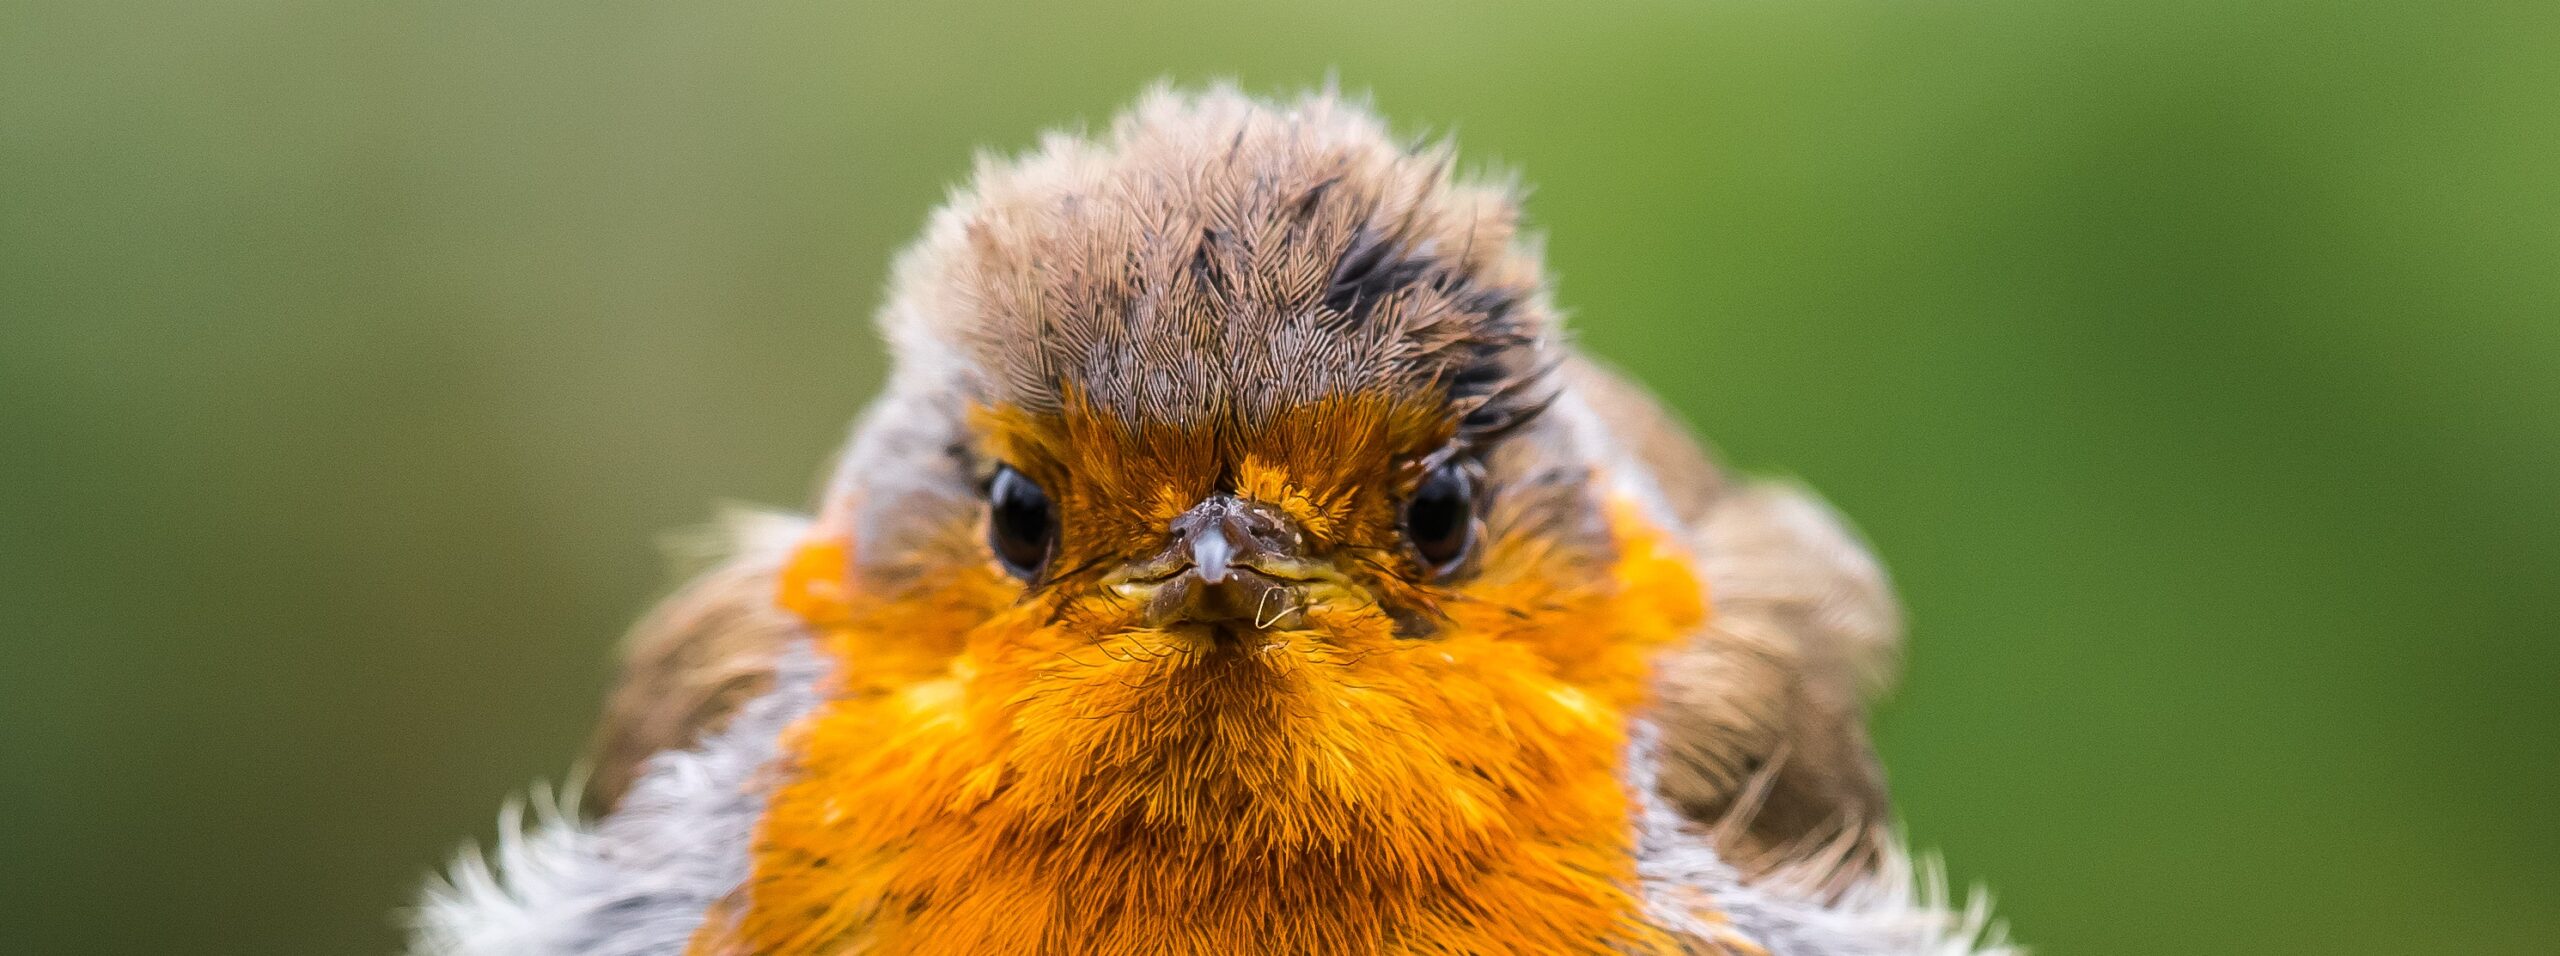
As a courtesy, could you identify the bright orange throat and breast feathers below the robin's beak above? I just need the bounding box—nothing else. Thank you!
[694,502,1697,956]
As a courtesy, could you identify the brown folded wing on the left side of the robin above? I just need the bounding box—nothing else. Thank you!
[584,513,809,815]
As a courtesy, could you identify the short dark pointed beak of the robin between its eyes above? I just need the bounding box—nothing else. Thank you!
[1108,495,1334,633]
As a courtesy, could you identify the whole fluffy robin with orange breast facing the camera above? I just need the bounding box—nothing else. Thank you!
[410,82,2012,956]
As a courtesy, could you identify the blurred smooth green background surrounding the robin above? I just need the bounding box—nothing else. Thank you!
[0,0,2560,956]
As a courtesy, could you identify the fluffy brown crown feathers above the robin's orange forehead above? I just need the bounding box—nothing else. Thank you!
[886,90,1554,436]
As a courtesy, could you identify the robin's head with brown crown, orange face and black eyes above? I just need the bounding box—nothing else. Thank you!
[786,95,1695,733]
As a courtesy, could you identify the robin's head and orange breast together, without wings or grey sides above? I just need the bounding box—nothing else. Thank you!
[694,97,1705,953]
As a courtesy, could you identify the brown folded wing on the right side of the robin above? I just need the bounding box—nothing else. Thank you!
[1572,361,1902,874]
